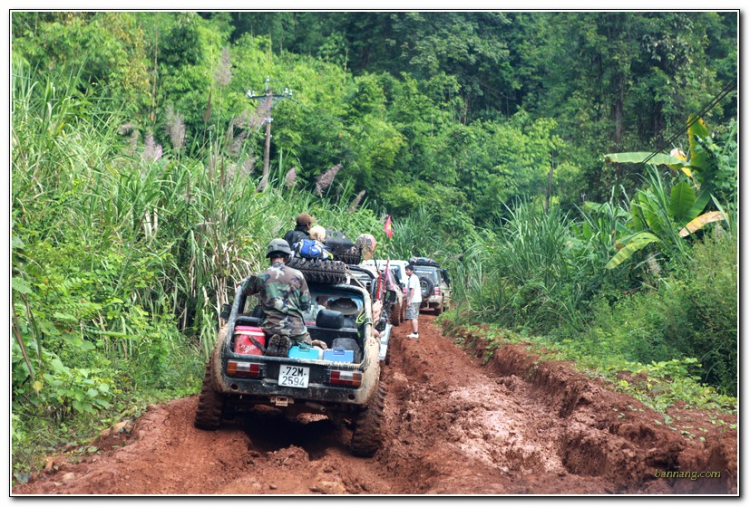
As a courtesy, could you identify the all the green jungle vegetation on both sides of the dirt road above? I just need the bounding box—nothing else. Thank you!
[11,12,739,480]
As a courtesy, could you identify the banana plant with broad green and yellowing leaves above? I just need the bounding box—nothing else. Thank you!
[604,117,727,269]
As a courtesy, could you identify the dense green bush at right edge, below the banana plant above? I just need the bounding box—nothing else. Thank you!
[585,228,737,396]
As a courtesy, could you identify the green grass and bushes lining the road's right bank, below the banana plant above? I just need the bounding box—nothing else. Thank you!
[452,195,737,396]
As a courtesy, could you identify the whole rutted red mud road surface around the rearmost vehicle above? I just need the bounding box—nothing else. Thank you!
[12,314,738,495]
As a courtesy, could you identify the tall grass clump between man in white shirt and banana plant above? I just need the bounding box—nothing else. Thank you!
[456,202,606,333]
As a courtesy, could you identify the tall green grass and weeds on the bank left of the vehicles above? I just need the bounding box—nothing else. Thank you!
[11,61,400,478]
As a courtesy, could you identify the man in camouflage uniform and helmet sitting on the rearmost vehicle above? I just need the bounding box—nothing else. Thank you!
[242,239,312,357]
